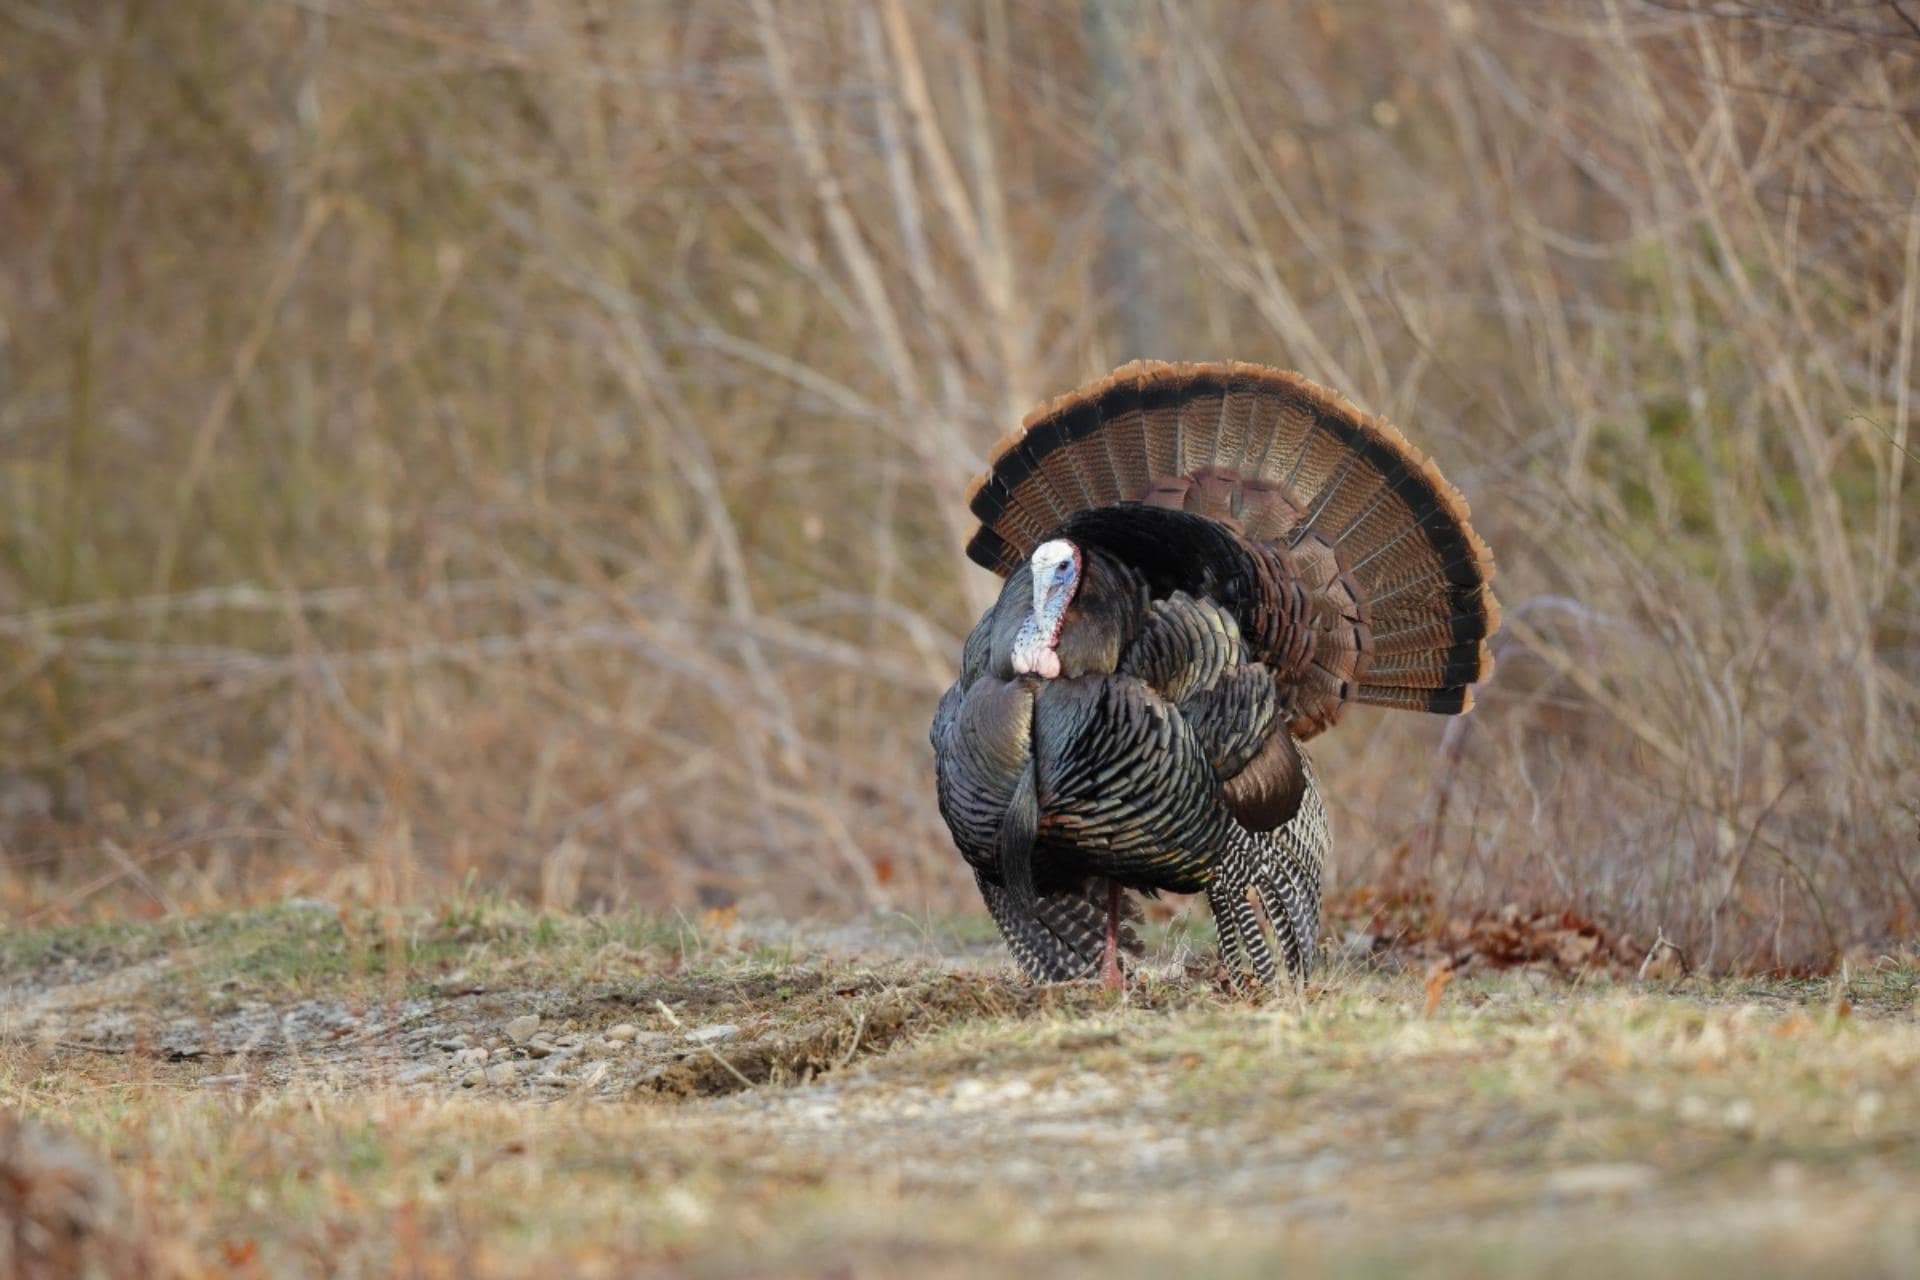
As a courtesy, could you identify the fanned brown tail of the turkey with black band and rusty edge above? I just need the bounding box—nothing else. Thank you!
[968,361,1500,735]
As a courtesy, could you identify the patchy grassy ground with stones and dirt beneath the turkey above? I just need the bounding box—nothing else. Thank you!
[0,904,1920,1276]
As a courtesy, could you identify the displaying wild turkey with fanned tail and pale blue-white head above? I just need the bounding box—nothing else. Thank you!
[931,363,1500,986]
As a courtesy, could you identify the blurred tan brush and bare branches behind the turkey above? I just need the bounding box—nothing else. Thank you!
[0,0,1920,969]
